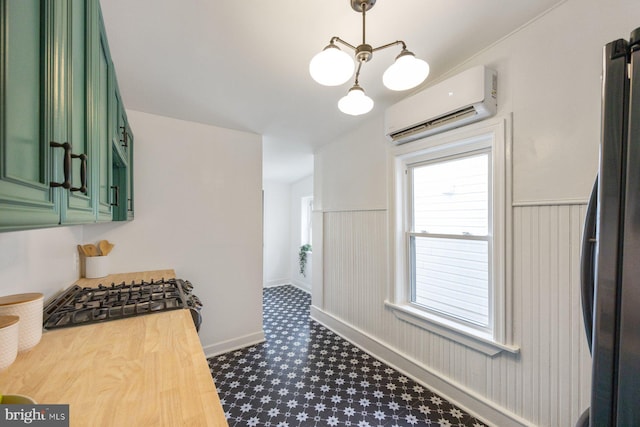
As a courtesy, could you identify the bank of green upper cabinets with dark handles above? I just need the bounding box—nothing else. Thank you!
[0,0,133,231]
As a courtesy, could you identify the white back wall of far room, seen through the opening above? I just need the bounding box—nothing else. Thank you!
[262,181,291,286]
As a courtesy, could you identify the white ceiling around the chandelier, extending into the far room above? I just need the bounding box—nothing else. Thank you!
[101,0,561,182]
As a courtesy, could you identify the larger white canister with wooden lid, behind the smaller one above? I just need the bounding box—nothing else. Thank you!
[0,293,44,352]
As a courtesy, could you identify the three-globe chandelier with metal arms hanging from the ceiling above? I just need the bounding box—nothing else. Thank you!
[309,0,429,116]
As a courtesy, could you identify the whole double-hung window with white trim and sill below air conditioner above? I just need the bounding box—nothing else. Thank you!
[387,120,517,355]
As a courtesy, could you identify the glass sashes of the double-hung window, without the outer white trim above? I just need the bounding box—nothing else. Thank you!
[407,152,491,330]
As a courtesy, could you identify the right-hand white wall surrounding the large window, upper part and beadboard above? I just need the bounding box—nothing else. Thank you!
[312,0,640,426]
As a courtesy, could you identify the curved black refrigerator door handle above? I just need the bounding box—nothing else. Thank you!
[580,178,598,352]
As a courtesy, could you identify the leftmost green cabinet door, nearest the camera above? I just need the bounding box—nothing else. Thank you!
[0,0,60,230]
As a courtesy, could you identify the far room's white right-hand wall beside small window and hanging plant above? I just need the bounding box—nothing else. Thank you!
[289,175,315,291]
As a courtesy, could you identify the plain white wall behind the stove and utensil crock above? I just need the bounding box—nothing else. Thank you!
[84,111,263,354]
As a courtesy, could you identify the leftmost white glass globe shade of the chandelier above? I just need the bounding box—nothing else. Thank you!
[309,44,355,86]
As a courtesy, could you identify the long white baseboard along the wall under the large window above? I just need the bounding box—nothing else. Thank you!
[311,305,533,427]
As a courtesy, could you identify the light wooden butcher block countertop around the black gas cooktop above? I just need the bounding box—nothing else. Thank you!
[0,270,227,427]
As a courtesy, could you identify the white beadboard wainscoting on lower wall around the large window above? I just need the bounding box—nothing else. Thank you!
[312,203,591,426]
